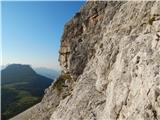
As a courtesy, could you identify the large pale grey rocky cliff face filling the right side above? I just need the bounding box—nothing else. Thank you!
[32,1,160,120]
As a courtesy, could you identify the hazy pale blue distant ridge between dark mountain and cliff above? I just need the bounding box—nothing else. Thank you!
[33,67,60,79]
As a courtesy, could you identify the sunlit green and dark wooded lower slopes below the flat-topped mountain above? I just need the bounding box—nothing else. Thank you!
[2,87,41,120]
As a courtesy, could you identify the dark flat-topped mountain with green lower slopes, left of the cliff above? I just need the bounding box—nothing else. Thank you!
[1,64,53,120]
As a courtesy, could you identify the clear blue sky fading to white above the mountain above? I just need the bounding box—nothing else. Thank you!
[2,1,84,69]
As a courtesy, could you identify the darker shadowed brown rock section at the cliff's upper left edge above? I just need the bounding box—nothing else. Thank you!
[59,2,107,78]
